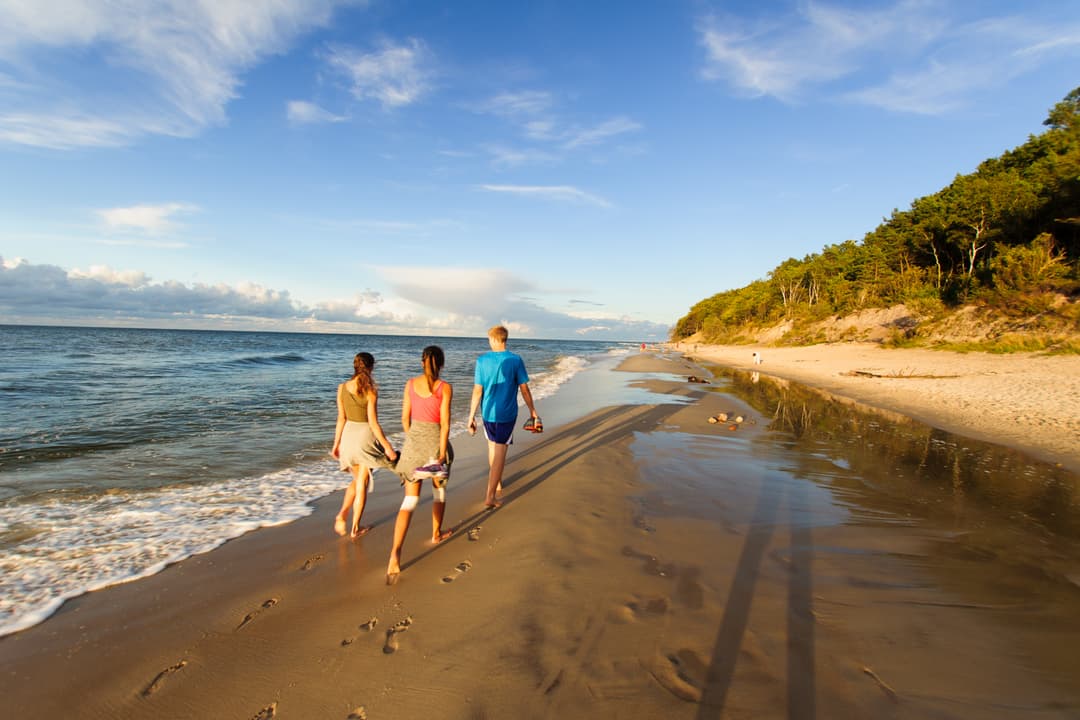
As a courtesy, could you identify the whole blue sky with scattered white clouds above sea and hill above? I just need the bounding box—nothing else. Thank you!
[0,0,1080,341]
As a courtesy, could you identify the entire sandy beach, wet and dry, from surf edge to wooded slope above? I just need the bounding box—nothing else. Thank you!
[0,347,1080,720]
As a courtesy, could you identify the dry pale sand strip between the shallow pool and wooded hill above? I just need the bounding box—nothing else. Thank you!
[683,343,1080,472]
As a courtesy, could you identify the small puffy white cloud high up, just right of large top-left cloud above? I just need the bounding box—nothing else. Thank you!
[326,39,433,108]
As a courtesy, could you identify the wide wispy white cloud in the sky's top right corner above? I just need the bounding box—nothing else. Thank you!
[699,0,1080,113]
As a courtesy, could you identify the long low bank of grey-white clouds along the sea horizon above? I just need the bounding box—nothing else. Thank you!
[0,257,667,339]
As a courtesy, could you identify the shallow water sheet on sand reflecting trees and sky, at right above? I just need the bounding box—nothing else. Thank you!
[633,370,1080,718]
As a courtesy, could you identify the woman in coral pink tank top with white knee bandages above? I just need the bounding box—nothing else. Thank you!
[387,345,454,585]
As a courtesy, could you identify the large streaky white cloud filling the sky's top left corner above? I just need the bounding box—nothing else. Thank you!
[0,0,348,149]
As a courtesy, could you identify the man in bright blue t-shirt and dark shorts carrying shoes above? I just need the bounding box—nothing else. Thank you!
[469,325,543,510]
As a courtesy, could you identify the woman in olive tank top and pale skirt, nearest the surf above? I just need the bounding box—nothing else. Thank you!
[330,353,397,538]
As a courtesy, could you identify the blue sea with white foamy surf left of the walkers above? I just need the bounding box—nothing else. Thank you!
[0,326,634,635]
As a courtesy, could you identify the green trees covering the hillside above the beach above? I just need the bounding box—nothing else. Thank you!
[672,87,1080,351]
